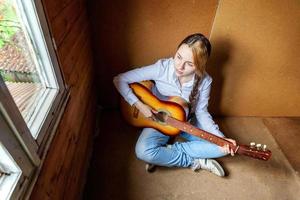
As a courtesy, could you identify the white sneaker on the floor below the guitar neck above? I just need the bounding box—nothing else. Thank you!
[191,158,225,176]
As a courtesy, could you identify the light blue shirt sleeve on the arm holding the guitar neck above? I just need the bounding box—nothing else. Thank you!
[195,77,224,137]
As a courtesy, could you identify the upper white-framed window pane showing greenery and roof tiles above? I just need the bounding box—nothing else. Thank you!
[0,0,58,138]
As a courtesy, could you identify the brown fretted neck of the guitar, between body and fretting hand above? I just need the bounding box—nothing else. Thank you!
[165,117,238,151]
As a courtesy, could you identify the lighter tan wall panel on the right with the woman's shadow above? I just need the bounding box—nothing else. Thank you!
[209,0,300,116]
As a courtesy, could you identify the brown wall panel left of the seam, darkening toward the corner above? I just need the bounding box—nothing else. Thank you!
[89,0,218,107]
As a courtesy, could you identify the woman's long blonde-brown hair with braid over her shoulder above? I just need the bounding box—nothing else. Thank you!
[178,33,211,118]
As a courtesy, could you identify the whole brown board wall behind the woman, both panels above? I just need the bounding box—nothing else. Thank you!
[89,0,300,116]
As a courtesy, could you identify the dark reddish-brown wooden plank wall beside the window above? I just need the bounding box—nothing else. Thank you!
[31,0,96,200]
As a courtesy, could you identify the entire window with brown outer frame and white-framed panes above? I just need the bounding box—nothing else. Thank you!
[0,0,68,199]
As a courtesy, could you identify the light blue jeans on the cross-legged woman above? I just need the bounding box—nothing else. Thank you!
[135,128,226,167]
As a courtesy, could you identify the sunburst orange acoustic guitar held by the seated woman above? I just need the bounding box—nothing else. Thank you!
[121,81,272,161]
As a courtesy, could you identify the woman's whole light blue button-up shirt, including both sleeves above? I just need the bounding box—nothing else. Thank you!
[114,58,224,137]
